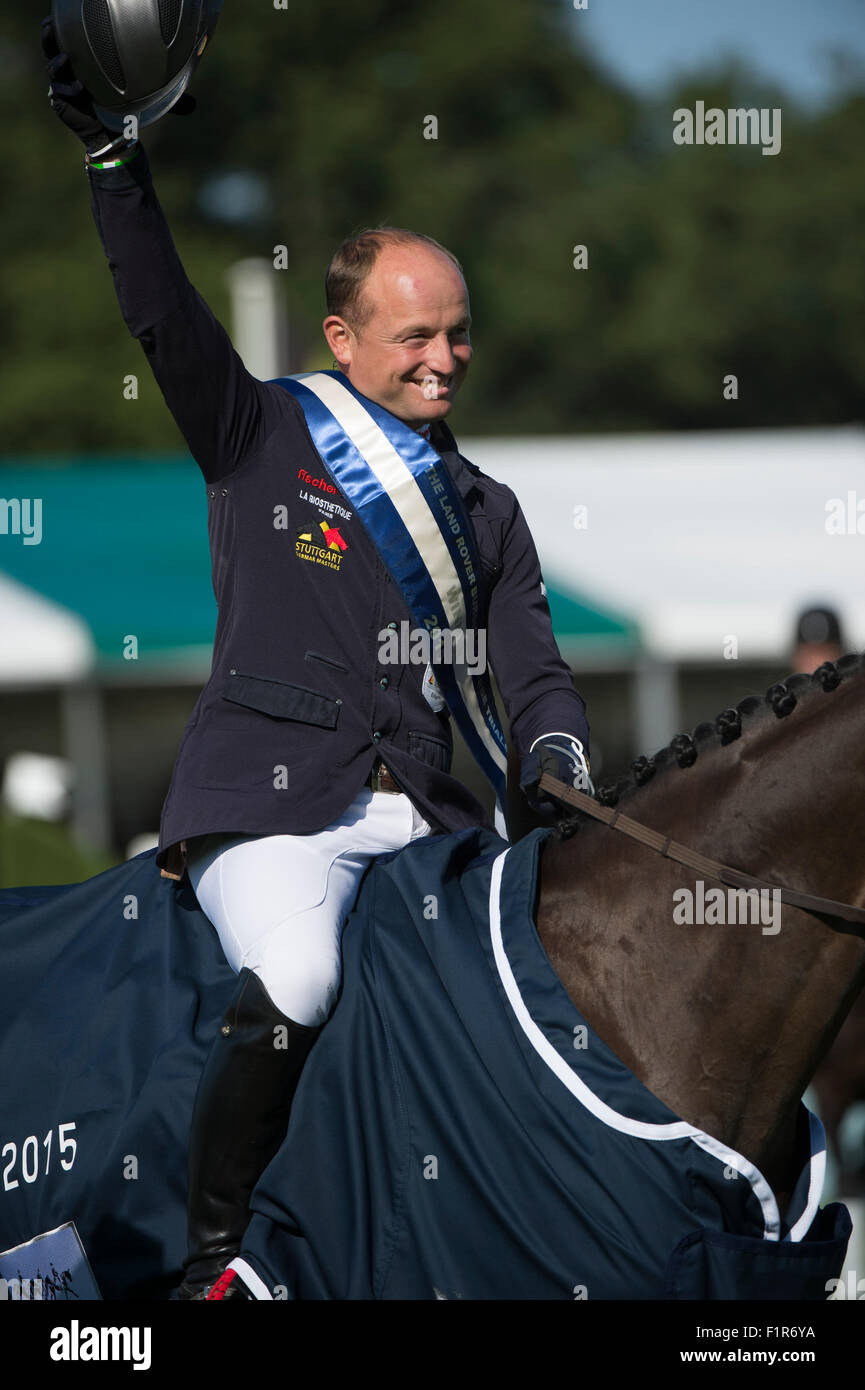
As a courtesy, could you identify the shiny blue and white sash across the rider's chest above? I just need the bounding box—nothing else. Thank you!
[274,371,508,837]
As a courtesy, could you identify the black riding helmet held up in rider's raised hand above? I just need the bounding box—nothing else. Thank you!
[51,0,223,131]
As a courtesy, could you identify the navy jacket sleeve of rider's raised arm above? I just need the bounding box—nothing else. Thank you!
[89,145,277,481]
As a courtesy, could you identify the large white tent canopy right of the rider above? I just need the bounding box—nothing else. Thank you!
[460,422,865,662]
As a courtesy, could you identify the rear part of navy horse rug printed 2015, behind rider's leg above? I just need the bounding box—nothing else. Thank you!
[0,851,235,1298]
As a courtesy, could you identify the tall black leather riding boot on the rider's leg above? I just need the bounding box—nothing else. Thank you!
[177,969,321,1298]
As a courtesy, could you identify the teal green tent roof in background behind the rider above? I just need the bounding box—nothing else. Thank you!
[0,455,638,669]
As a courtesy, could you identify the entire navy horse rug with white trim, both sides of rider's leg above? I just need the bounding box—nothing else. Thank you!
[0,830,851,1300]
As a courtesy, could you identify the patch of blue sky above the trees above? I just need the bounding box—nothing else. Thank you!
[562,0,865,107]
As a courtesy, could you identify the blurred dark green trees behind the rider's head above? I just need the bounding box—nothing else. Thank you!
[0,0,865,453]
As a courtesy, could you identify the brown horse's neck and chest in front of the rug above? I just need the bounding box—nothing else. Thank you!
[538,678,865,1200]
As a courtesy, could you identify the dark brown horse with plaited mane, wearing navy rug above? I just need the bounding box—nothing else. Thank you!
[0,656,865,1298]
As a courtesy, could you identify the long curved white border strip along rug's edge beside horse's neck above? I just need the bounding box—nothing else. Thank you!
[490,849,784,1240]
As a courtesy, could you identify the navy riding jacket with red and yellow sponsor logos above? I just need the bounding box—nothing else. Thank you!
[89,146,588,877]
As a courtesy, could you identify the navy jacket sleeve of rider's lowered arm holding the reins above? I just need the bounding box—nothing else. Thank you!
[487,498,588,756]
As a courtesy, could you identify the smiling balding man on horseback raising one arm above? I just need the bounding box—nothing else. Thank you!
[43,24,588,1298]
